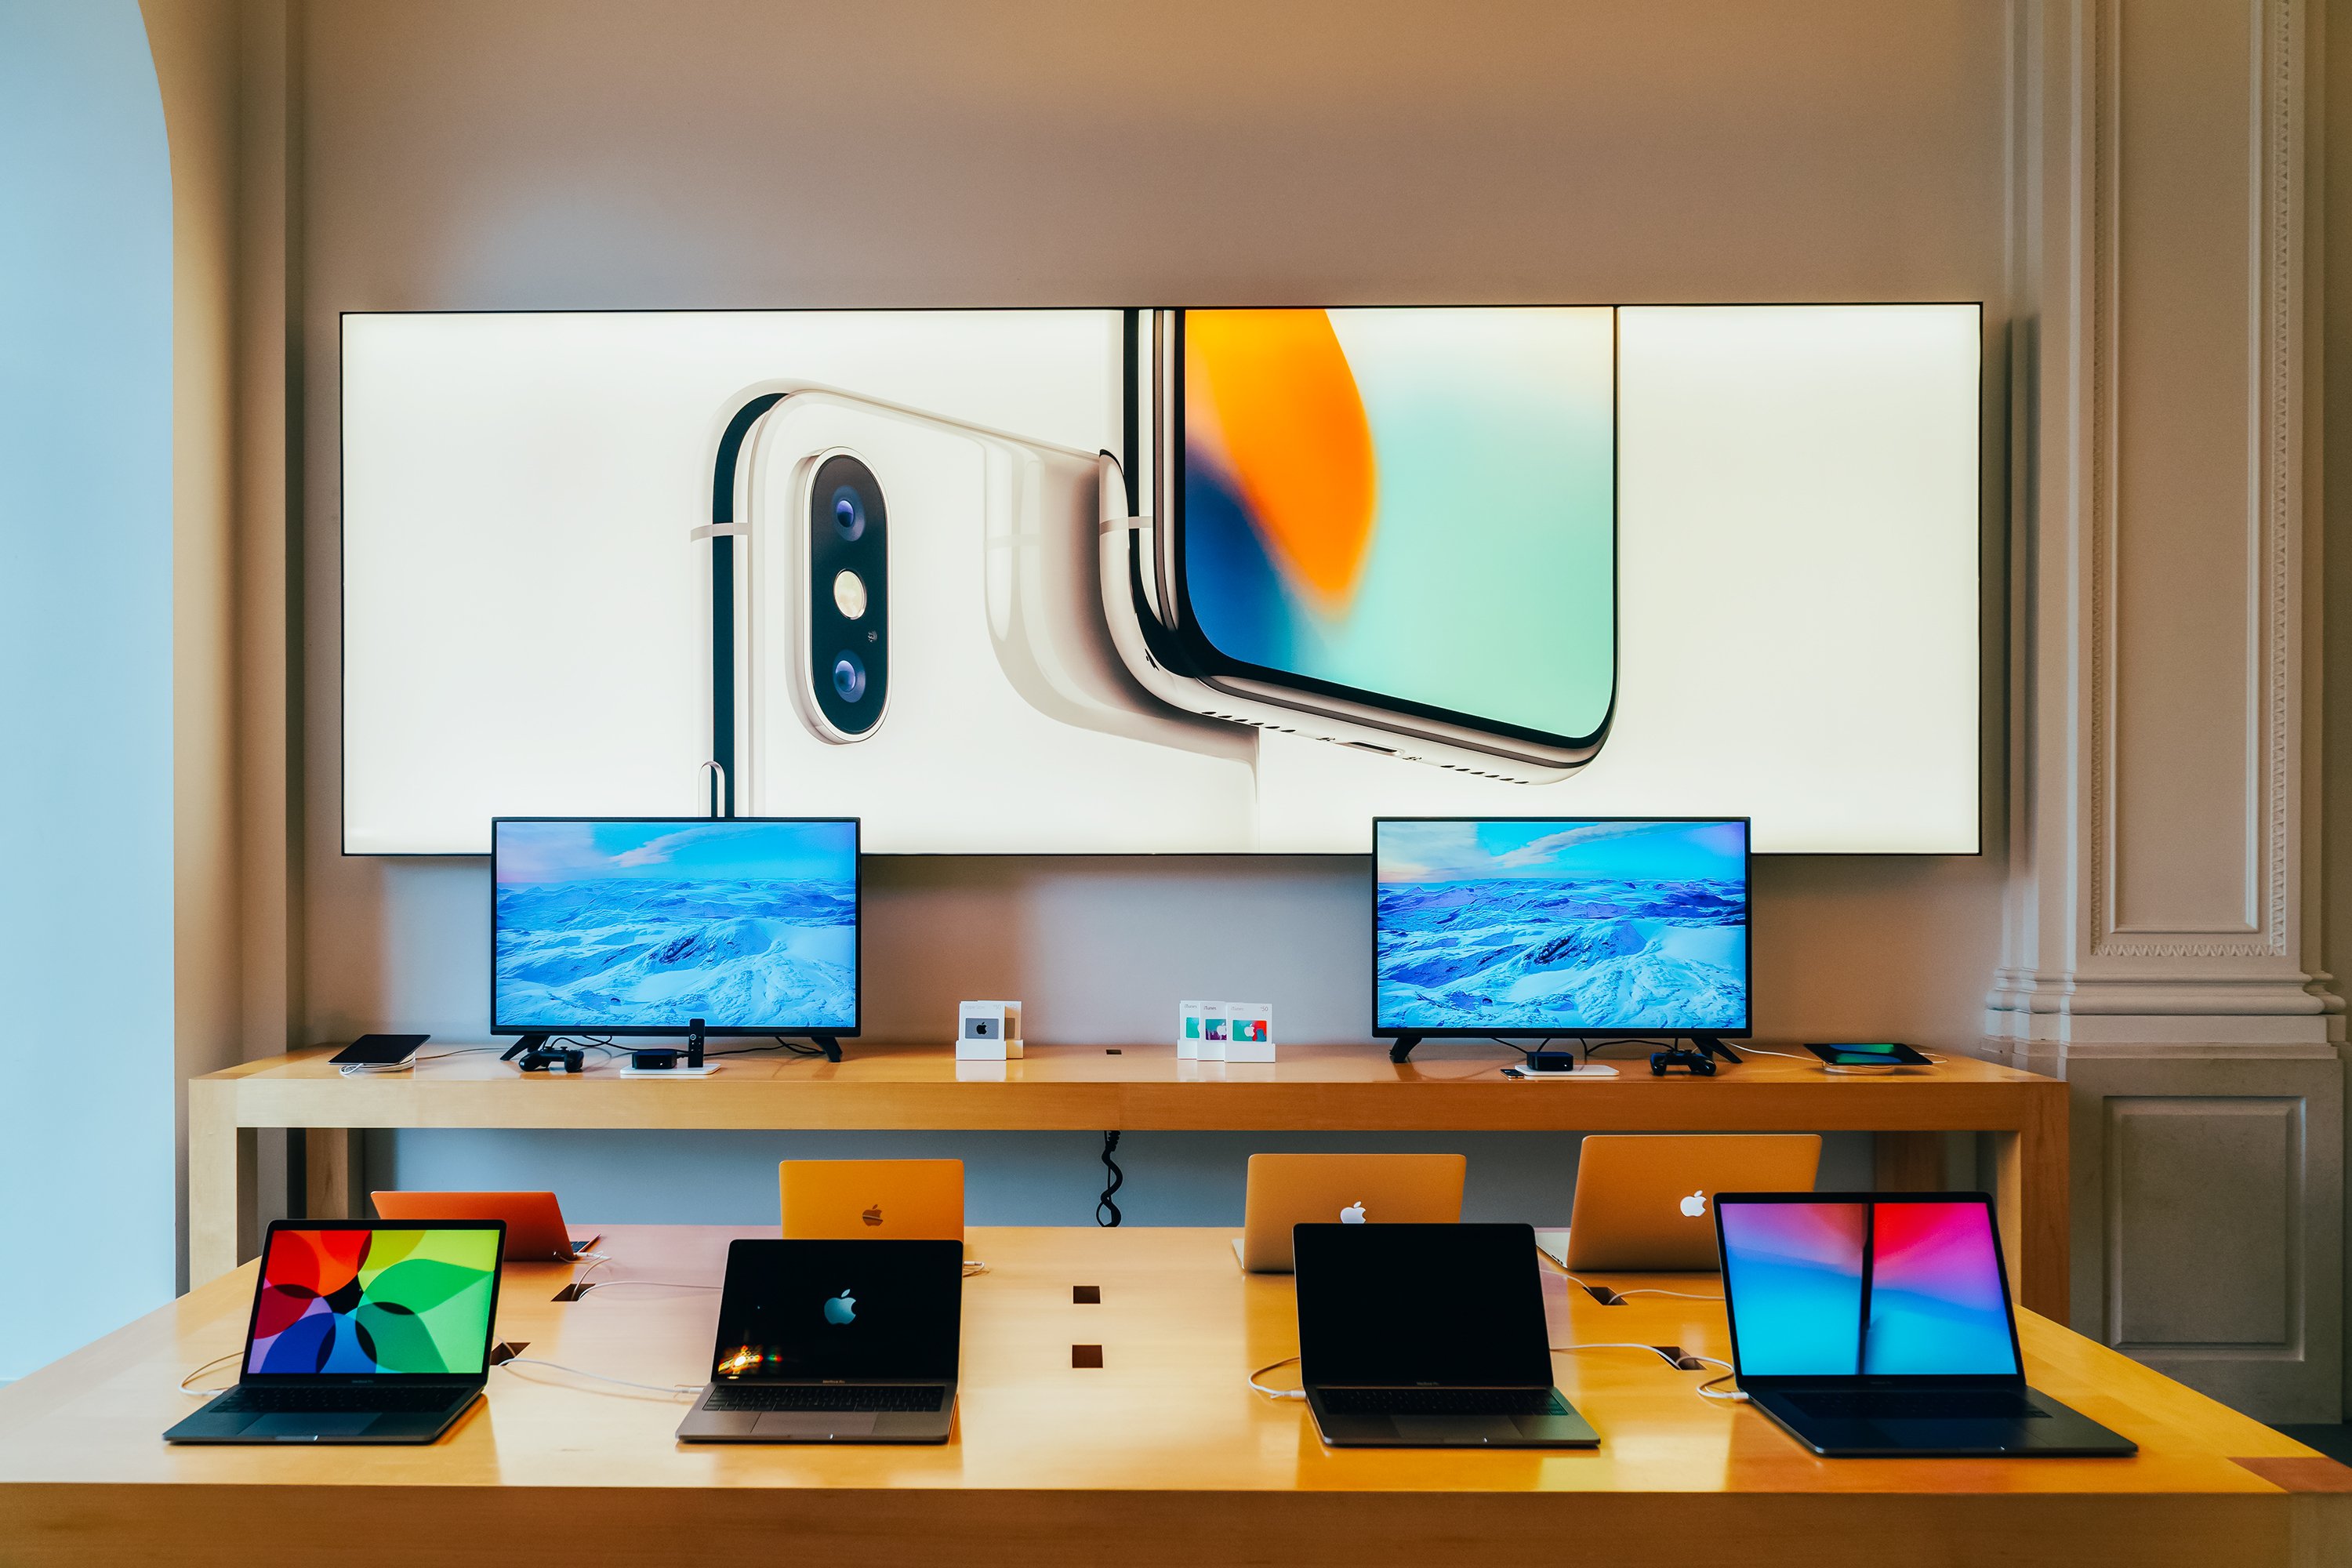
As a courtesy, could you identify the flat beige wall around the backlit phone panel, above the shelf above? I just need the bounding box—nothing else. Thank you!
[303,2,2004,1044]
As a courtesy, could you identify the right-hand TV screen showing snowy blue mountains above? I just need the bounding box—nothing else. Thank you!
[1374,820,1748,1032]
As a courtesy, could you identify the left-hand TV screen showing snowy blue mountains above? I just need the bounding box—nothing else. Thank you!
[492,820,858,1034]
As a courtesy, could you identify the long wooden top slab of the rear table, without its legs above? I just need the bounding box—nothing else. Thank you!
[193,1041,2065,1131]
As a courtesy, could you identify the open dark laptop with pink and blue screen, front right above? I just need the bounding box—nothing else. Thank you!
[1715,1192,2138,1455]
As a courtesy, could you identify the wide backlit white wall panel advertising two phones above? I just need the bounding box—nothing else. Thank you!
[343,306,1980,853]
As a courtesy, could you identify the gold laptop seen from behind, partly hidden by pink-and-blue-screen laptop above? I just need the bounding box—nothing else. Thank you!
[1536,1133,1820,1274]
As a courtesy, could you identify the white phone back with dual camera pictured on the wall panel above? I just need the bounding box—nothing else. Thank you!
[703,381,1256,851]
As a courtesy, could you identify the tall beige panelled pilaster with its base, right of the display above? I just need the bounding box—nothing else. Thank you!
[1985,0,2345,1420]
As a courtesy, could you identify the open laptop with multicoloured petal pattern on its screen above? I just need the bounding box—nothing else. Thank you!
[162,1220,506,1443]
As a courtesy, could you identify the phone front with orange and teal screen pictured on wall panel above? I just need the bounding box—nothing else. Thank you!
[1103,306,1616,783]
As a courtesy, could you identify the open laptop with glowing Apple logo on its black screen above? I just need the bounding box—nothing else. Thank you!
[677,1241,964,1443]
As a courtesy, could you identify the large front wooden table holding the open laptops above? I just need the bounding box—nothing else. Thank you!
[0,1227,2352,1568]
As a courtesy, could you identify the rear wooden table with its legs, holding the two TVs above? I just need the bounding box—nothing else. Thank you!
[188,1041,2067,1321]
